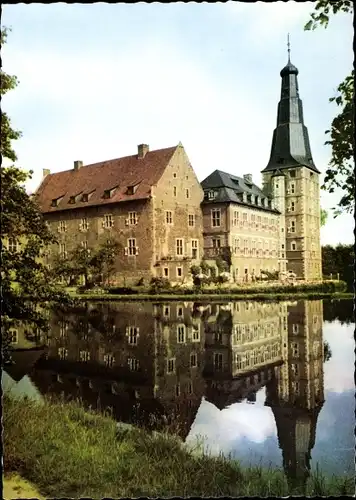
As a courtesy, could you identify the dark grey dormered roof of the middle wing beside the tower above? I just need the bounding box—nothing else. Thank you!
[201,170,279,213]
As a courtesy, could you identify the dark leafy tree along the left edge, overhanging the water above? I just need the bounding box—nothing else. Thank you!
[0,28,71,363]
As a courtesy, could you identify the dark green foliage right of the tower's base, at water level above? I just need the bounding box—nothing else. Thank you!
[321,245,355,291]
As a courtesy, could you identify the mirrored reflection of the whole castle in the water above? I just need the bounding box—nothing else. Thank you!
[13,300,324,485]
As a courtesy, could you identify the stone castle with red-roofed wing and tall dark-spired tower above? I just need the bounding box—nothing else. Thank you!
[35,56,322,284]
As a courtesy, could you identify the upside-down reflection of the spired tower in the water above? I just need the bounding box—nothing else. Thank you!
[266,300,324,495]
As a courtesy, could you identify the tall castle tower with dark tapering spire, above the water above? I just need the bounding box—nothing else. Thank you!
[262,45,322,280]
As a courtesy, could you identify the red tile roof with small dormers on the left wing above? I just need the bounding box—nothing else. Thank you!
[35,146,177,213]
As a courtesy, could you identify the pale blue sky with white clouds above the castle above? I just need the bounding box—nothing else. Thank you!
[2,1,354,245]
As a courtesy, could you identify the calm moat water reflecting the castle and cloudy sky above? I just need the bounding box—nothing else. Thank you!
[3,300,355,488]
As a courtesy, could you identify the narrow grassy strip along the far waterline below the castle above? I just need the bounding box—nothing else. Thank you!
[71,292,354,302]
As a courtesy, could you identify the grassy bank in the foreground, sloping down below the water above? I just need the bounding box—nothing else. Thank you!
[3,396,354,498]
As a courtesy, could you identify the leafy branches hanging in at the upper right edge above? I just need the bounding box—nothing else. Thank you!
[304,0,355,217]
